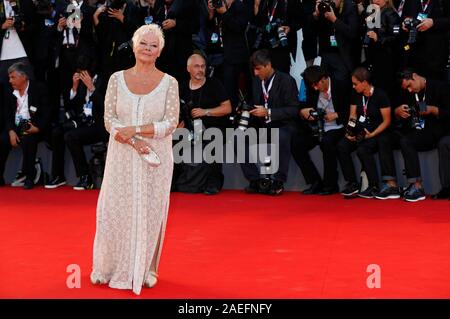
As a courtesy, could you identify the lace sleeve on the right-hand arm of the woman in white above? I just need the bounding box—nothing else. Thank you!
[153,78,180,138]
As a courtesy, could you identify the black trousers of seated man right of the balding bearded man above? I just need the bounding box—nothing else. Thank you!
[239,125,298,183]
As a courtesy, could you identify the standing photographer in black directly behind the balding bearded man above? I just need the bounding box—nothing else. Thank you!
[206,0,251,107]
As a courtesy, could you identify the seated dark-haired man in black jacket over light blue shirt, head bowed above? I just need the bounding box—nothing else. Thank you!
[292,65,351,195]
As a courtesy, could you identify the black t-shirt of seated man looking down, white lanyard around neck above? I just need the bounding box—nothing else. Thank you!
[352,88,391,132]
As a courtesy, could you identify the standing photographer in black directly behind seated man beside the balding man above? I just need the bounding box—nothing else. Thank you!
[247,0,304,74]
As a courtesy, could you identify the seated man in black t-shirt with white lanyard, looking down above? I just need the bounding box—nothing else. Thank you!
[338,67,391,198]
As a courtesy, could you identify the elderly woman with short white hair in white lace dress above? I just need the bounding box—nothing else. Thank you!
[91,24,179,294]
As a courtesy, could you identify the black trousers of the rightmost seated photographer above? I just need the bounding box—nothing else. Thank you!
[379,126,441,183]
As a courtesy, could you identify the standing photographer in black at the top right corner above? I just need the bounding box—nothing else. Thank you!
[402,0,450,80]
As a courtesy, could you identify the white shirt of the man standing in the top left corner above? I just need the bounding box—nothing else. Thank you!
[0,0,27,61]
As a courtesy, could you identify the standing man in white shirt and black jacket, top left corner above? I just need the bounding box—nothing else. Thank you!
[0,0,34,85]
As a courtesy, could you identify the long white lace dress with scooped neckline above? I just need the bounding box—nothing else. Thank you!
[91,71,179,294]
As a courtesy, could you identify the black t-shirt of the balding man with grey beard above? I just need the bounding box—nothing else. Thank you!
[180,78,229,128]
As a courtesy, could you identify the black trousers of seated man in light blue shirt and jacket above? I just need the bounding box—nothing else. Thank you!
[292,128,345,188]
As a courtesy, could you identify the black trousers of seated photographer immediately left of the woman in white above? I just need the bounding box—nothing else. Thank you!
[64,125,109,177]
